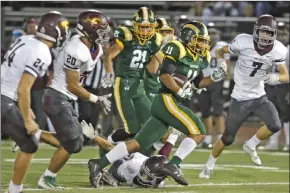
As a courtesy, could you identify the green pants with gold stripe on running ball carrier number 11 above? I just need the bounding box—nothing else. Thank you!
[135,94,206,151]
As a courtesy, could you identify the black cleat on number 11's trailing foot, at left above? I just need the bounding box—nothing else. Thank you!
[88,159,103,188]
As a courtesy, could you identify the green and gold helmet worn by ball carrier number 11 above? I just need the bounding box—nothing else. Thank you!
[179,21,210,57]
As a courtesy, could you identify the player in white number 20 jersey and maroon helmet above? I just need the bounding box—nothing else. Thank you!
[38,10,111,189]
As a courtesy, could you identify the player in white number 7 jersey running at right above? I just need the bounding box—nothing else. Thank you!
[199,15,289,178]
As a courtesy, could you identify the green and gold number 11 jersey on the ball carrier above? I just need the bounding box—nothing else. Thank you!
[161,40,211,98]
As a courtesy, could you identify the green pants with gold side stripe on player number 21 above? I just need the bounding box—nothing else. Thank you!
[114,77,151,134]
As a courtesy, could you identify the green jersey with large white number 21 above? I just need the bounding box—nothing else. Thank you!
[114,27,162,78]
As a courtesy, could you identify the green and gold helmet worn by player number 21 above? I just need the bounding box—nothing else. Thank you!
[133,7,157,45]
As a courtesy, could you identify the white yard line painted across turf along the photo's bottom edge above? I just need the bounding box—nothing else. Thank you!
[10,182,289,191]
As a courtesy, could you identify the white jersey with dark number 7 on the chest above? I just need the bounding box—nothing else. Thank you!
[229,34,287,100]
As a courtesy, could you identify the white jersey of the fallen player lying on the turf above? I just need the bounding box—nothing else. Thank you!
[117,152,148,185]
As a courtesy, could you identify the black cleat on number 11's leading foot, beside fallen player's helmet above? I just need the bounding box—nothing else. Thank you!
[163,163,188,186]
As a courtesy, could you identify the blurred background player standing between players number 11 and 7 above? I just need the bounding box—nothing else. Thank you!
[197,22,230,148]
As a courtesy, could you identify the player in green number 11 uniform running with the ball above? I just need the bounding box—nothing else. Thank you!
[89,21,227,186]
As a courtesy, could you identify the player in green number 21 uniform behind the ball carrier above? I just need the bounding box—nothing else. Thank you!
[102,7,162,144]
